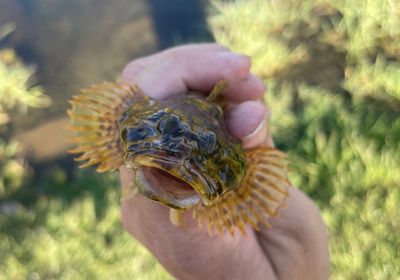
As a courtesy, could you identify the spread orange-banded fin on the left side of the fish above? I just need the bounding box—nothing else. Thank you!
[67,83,141,172]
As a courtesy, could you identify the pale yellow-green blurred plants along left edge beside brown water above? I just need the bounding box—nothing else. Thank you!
[0,24,49,199]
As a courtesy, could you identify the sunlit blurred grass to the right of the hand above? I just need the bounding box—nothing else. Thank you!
[210,0,400,279]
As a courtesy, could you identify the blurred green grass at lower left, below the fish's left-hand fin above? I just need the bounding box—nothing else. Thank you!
[0,170,171,279]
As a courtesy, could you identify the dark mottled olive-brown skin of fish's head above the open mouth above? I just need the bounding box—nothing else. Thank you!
[119,95,246,207]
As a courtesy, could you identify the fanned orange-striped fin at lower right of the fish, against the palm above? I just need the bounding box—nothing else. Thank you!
[193,147,290,236]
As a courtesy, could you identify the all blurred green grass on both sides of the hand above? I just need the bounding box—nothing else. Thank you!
[0,0,400,279]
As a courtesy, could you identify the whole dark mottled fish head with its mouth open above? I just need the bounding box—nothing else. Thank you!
[119,96,246,209]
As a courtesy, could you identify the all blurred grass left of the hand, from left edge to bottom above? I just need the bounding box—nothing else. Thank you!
[0,25,171,280]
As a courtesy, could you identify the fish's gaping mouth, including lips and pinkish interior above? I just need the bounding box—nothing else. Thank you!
[125,154,218,210]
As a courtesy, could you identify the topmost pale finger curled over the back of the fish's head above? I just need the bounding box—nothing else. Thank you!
[125,51,250,99]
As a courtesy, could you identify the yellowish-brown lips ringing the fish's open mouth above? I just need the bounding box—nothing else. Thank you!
[125,150,219,210]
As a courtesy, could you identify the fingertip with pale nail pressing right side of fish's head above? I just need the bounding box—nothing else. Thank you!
[226,101,273,149]
